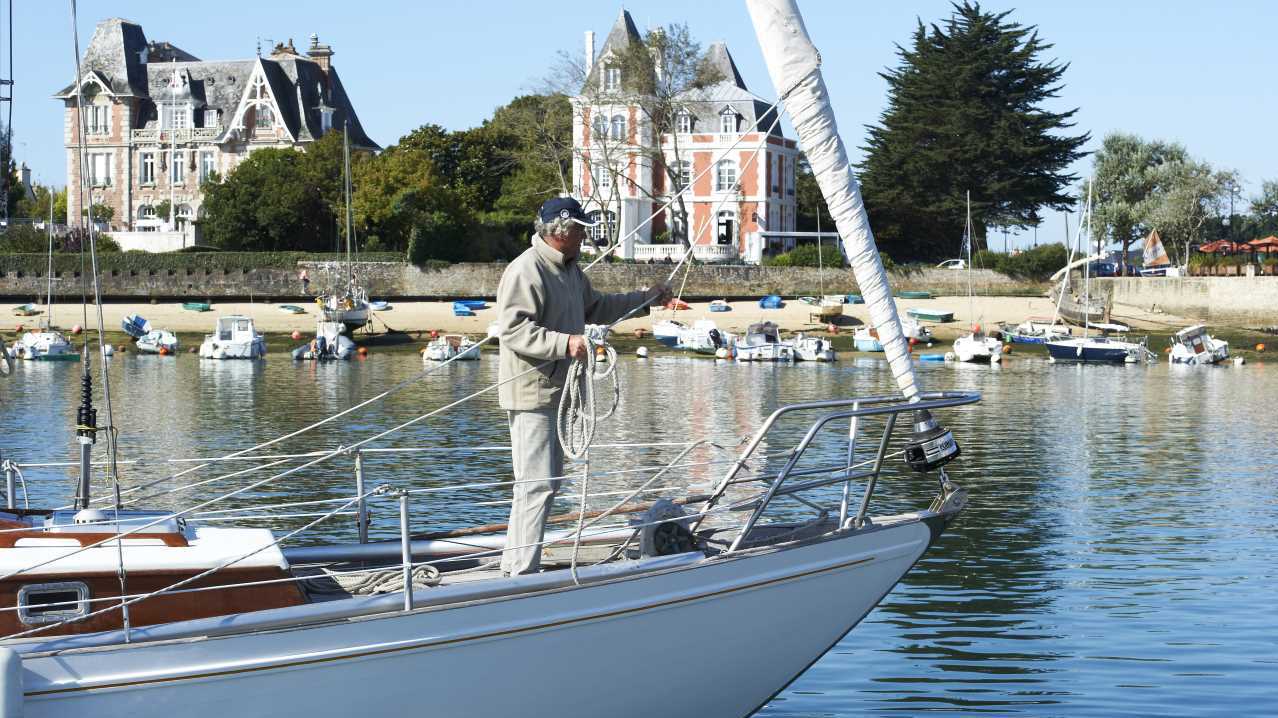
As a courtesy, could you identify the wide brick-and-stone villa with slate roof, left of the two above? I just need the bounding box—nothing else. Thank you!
[55,19,380,231]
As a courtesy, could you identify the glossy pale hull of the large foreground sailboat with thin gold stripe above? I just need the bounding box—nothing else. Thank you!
[15,520,932,718]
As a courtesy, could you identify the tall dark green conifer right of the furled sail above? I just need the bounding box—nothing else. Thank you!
[860,0,1088,259]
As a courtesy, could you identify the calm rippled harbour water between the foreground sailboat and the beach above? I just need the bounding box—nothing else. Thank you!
[0,351,1278,717]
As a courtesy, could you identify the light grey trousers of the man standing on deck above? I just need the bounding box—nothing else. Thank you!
[501,408,564,576]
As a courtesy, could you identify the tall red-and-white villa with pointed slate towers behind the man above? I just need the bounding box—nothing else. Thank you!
[573,10,799,262]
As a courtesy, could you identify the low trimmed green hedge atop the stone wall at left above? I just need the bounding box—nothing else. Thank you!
[0,252,404,276]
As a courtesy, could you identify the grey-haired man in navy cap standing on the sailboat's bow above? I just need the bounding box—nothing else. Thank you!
[497,197,671,576]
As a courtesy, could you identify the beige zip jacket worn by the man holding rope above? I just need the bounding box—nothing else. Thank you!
[497,235,648,411]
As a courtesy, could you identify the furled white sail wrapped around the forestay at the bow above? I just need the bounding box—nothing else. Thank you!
[745,0,919,399]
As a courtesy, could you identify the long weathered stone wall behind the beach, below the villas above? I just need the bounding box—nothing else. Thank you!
[0,262,1047,302]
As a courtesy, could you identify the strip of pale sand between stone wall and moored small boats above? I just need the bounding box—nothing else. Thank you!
[0,296,1187,339]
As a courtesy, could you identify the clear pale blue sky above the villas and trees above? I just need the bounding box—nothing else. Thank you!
[5,0,1278,248]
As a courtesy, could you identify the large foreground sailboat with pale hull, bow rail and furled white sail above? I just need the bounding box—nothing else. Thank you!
[0,0,979,718]
